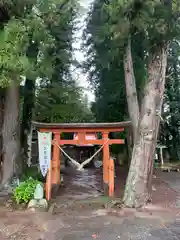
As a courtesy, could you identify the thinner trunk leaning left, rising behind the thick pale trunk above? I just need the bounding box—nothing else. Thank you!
[124,38,139,140]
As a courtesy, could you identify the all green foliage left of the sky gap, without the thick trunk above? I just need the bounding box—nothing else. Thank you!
[0,0,93,127]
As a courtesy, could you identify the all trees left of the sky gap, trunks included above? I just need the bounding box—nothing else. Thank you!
[0,0,94,189]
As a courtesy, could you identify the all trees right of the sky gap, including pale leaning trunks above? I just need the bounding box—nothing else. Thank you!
[85,0,180,207]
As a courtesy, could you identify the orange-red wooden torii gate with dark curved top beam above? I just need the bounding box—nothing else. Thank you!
[33,121,131,200]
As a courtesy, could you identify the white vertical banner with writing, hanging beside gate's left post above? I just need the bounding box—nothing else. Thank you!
[38,132,52,177]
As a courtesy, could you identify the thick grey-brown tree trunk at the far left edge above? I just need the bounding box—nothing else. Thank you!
[1,80,21,187]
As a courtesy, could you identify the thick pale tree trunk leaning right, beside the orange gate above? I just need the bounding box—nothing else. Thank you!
[124,47,167,207]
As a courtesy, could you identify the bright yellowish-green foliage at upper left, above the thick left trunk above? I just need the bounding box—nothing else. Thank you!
[0,1,53,87]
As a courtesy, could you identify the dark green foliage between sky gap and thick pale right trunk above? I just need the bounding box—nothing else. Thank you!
[84,0,146,122]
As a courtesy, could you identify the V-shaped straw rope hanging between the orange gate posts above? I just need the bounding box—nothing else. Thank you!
[53,139,109,171]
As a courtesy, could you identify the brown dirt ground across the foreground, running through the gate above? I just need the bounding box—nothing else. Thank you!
[0,166,180,240]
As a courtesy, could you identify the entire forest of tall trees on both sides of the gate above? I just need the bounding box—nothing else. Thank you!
[0,0,180,207]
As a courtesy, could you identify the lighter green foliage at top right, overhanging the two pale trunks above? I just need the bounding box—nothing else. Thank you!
[104,0,180,51]
